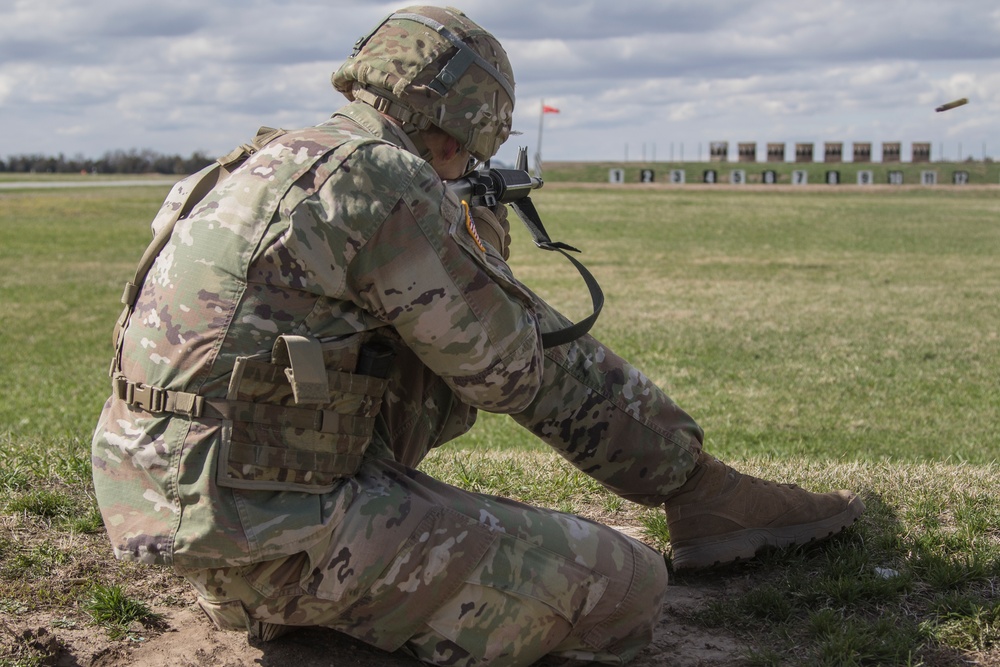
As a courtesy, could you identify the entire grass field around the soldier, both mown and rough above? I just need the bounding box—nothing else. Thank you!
[0,179,1000,667]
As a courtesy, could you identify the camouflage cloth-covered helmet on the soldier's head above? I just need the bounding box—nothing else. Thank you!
[332,6,514,161]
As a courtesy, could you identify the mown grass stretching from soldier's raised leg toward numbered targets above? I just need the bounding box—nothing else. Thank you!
[458,187,1000,462]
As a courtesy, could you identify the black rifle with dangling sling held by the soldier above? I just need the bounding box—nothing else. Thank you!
[445,146,604,348]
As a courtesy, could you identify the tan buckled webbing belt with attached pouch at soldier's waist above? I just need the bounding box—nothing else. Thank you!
[113,348,391,493]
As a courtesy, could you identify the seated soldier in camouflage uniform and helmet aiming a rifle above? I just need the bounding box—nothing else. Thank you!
[93,7,863,665]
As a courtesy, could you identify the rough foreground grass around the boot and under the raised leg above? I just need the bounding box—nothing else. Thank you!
[423,454,1000,667]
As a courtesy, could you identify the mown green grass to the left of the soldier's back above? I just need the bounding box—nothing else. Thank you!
[0,187,160,439]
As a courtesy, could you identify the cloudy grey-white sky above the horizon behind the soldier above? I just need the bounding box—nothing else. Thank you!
[0,0,1000,166]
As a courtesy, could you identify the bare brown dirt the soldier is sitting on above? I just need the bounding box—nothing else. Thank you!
[0,583,744,667]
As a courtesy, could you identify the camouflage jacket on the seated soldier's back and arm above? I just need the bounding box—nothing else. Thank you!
[93,103,543,568]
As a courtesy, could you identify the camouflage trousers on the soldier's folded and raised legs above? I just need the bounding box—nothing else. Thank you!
[184,300,701,666]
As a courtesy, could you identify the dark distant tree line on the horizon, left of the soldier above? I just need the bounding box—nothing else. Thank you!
[0,148,214,174]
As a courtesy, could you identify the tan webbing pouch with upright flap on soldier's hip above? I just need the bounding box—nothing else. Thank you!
[217,334,389,493]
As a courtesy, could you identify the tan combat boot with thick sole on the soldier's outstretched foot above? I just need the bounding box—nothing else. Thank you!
[665,452,865,570]
